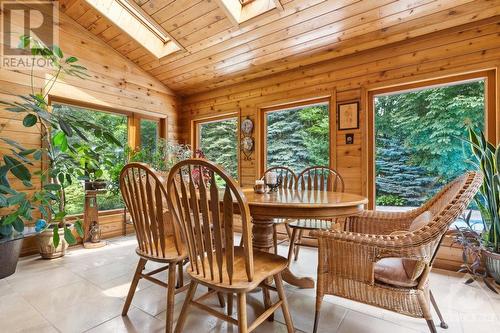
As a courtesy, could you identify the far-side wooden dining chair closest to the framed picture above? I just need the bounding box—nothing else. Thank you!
[288,166,344,261]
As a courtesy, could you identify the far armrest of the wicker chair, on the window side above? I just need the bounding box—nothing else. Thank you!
[346,208,422,235]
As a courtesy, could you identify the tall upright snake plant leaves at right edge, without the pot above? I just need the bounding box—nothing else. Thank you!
[469,128,500,253]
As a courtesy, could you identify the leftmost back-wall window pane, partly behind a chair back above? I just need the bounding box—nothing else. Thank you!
[198,118,238,179]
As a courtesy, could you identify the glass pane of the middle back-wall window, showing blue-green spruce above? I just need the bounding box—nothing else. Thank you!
[266,103,330,174]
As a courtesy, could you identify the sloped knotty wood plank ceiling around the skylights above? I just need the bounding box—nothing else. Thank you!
[60,0,500,95]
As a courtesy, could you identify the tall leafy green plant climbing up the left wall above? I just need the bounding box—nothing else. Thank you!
[0,36,119,247]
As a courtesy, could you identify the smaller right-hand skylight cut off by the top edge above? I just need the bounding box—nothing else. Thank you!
[218,0,278,24]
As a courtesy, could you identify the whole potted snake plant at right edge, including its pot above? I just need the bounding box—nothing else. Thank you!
[458,128,500,288]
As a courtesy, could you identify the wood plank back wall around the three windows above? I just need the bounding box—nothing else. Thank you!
[180,16,500,268]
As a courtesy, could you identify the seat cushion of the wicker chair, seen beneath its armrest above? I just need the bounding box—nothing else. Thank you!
[374,258,418,288]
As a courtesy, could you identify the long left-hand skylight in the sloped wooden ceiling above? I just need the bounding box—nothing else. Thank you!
[86,0,181,58]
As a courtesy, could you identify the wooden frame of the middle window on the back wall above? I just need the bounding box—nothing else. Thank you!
[258,96,336,175]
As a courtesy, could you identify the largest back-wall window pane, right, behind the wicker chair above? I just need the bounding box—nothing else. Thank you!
[375,80,485,214]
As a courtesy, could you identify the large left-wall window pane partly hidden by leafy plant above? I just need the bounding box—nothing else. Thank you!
[53,104,127,214]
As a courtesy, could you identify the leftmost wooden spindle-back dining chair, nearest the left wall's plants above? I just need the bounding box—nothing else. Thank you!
[120,163,188,333]
